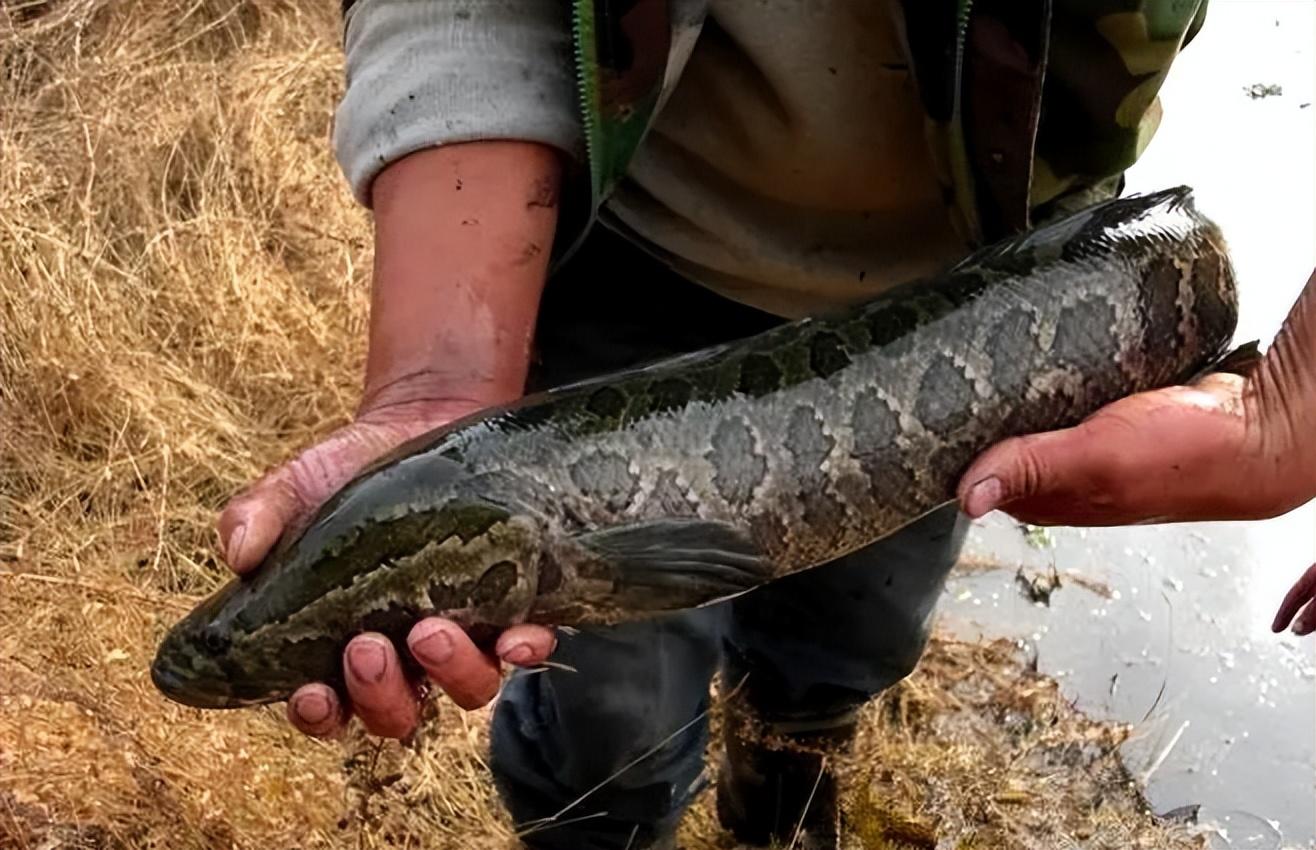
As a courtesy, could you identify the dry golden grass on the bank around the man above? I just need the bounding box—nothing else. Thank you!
[0,0,1205,850]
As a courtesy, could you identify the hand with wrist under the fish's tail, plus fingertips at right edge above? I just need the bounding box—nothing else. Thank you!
[957,274,1316,634]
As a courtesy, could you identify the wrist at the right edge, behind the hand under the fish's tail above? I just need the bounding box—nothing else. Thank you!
[1244,265,1316,507]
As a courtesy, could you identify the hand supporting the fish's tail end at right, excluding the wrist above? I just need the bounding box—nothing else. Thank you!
[958,375,1289,526]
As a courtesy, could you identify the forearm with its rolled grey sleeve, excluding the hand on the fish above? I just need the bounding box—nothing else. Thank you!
[327,0,582,409]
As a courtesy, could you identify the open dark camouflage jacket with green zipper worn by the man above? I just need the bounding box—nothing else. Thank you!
[558,0,1207,258]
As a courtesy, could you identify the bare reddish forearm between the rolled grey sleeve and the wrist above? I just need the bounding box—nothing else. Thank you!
[362,141,561,409]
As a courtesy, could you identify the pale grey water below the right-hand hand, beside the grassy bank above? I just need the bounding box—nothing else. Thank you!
[942,508,1316,849]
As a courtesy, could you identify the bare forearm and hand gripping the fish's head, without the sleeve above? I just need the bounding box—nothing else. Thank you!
[220,142,561,738]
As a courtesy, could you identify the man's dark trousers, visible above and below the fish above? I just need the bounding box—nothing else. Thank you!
[492,228,966,850]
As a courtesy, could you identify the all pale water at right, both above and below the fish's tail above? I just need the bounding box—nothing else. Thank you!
[942,0,1316,850]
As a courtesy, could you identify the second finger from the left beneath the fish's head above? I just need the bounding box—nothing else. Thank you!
[343,633,420,738]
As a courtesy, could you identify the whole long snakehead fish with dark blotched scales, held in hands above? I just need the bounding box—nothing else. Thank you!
[151,187,1237,708]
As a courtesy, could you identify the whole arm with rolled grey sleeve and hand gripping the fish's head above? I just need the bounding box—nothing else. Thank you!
[211,0,582,737]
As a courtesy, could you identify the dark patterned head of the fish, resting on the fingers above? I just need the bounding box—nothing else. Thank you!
[151,453,545,708]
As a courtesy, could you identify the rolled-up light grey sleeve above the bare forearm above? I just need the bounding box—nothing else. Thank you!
[333,0,583,207]
